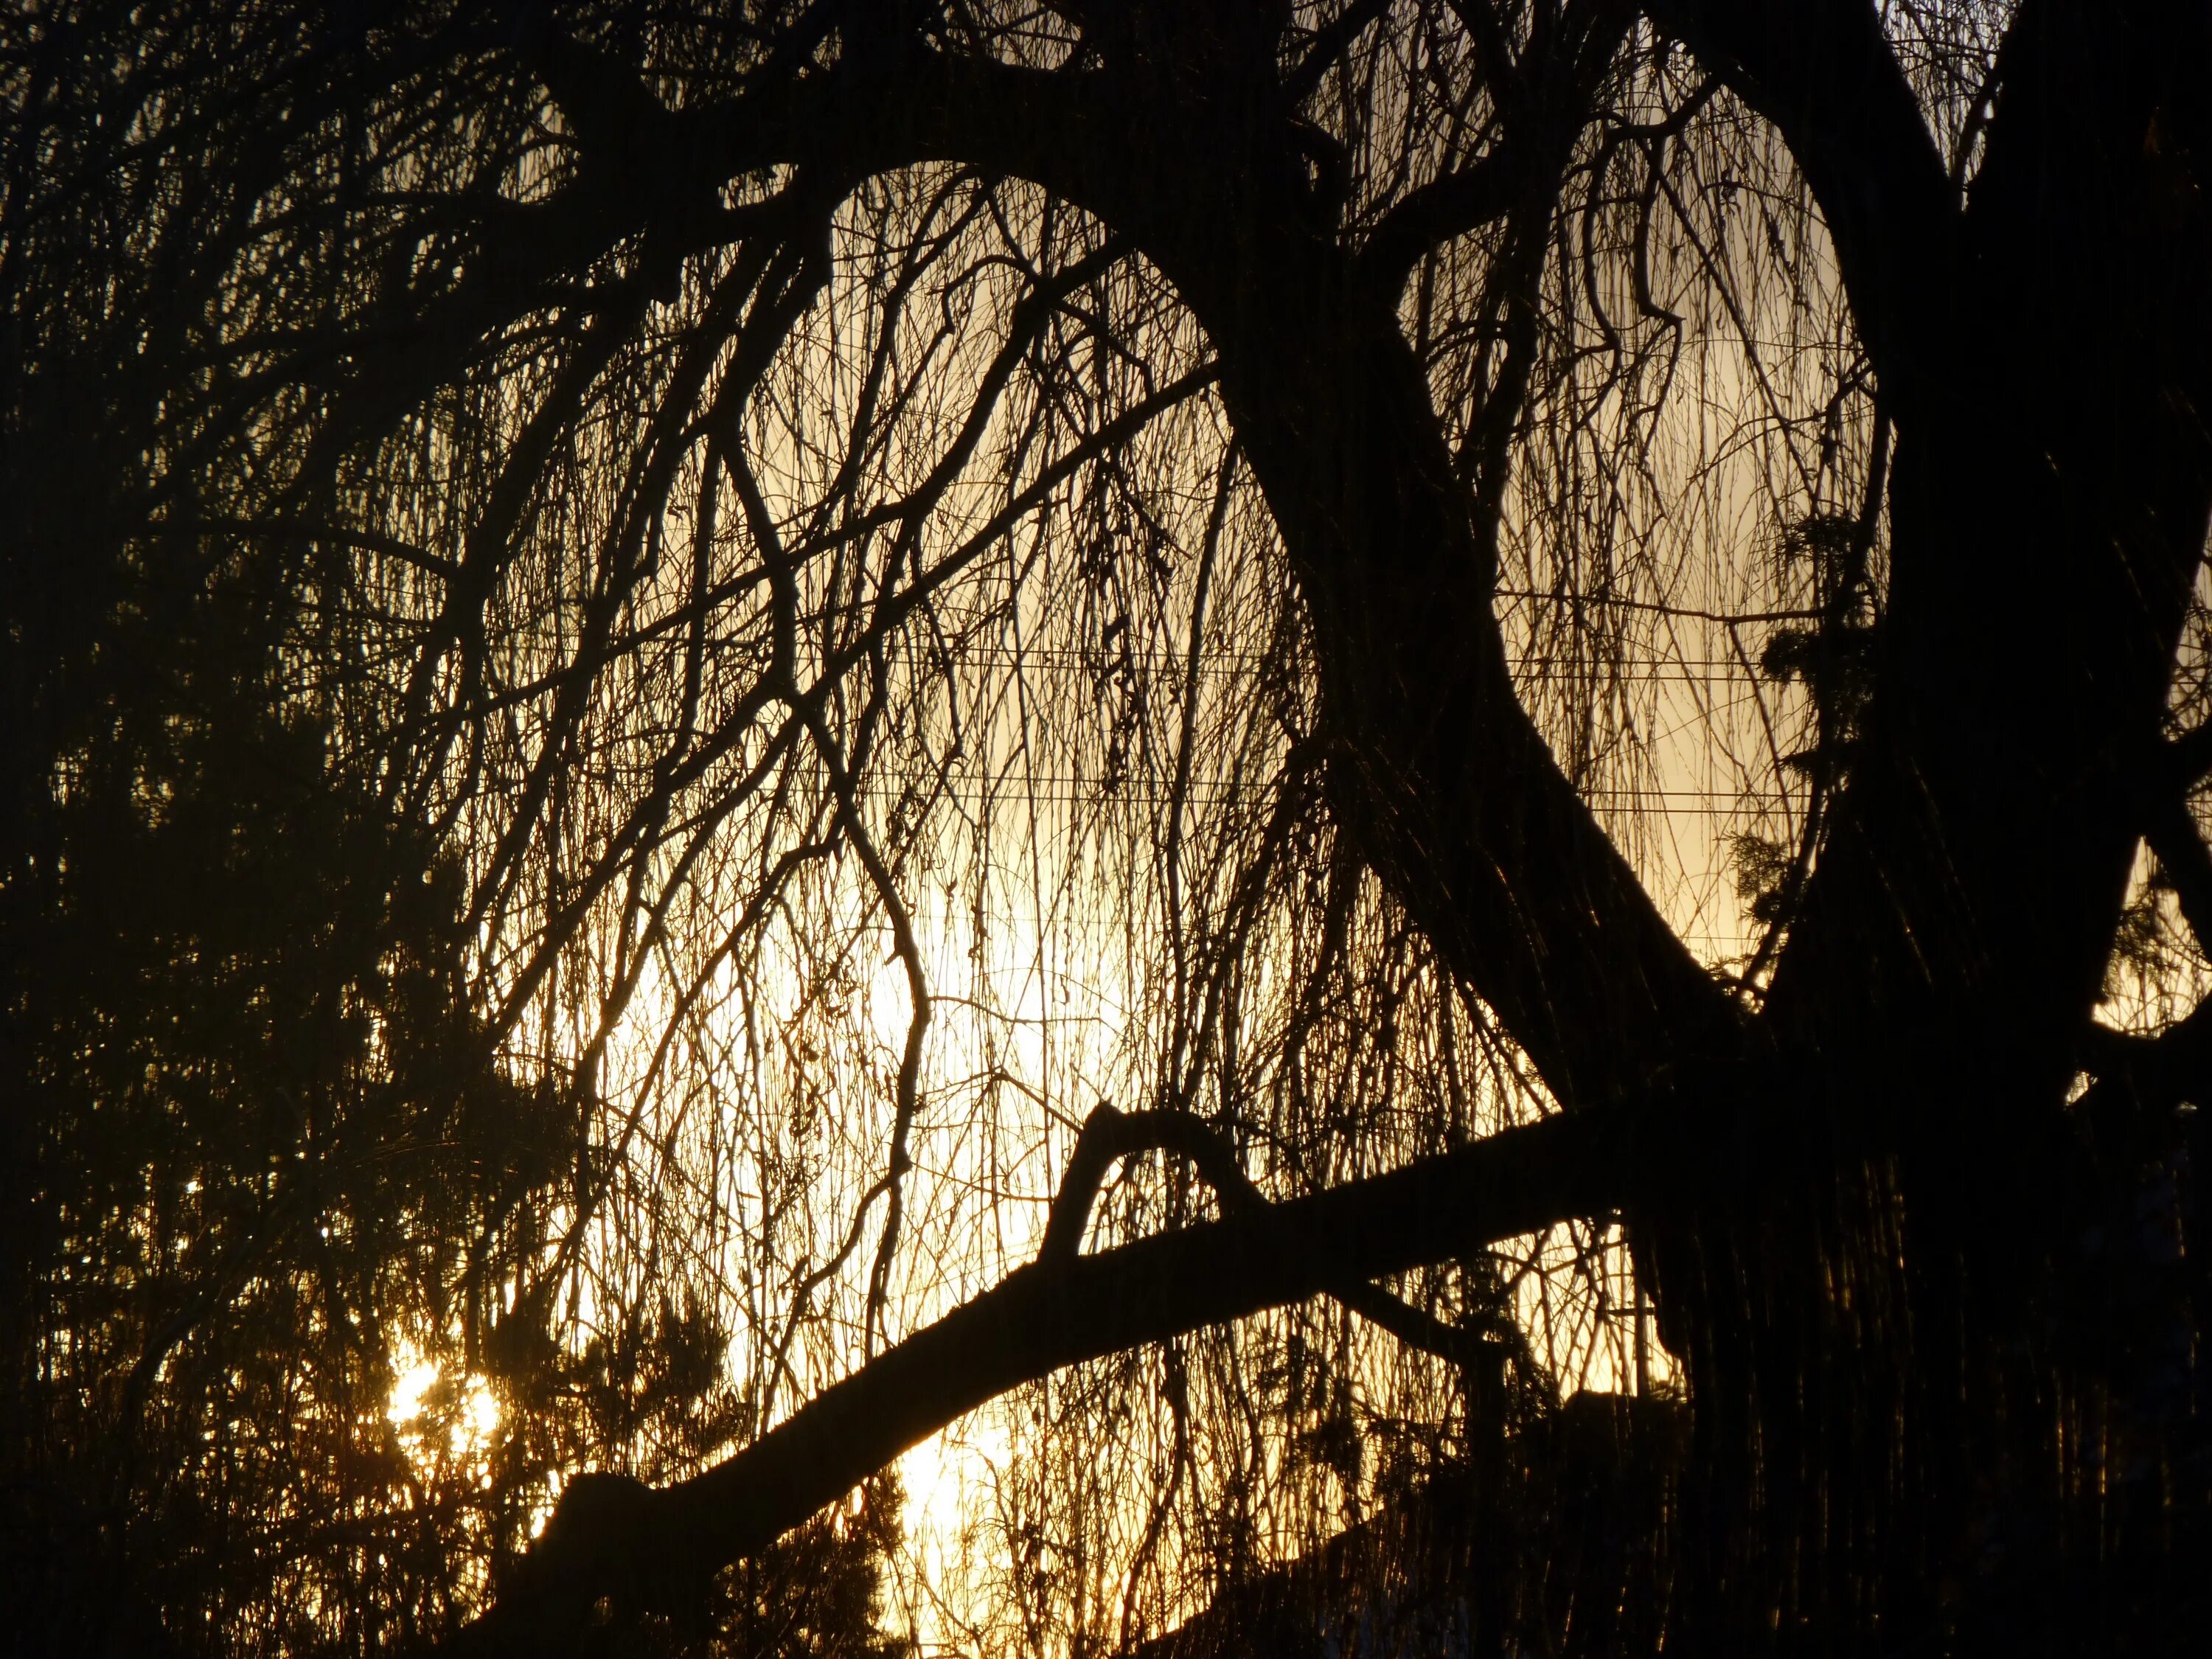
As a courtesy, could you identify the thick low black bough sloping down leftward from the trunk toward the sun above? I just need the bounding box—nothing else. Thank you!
[451,1110,1659,1655]
